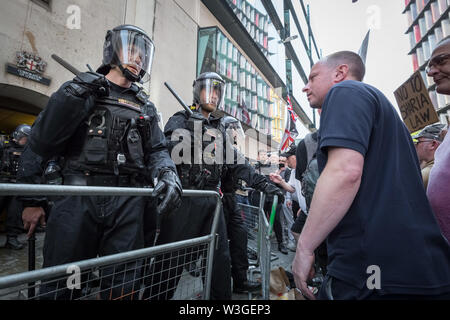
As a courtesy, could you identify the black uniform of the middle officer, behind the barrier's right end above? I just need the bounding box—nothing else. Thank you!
[144,111,243,300]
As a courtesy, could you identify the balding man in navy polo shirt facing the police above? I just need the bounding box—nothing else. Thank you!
[292,51,450,299]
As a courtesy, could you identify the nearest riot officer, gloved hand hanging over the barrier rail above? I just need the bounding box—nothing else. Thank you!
[23,25,182,299]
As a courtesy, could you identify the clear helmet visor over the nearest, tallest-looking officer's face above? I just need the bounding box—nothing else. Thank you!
[112,30,155,82]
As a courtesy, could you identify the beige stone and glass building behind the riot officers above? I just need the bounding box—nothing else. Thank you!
[0,0,319,159]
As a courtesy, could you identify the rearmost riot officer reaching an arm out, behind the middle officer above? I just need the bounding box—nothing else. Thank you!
[221,116,283,293]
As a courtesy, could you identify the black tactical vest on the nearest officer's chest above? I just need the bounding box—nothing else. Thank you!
[63,81,150,175]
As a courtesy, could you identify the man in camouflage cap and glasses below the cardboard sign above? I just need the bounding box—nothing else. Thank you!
[413,123,445,190]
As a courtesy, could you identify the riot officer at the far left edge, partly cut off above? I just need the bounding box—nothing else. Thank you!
[0,124,31,250]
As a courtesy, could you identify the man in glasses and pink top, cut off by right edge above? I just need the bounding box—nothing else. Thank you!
[427,36,450,241]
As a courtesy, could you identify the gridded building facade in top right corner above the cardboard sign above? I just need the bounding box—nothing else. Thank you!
[403,0,450,123]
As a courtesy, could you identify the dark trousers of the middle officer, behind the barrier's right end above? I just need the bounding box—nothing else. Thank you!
[143,197,231,300]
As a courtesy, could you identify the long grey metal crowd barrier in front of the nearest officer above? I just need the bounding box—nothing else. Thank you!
[0,184,222,300]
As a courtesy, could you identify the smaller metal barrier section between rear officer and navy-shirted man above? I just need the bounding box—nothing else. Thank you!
[238,193,278,300]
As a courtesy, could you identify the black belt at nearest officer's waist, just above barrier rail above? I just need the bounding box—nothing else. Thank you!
[63,174,144,187]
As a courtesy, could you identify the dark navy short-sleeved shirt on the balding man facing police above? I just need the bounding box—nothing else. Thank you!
[318,81,450,295]
